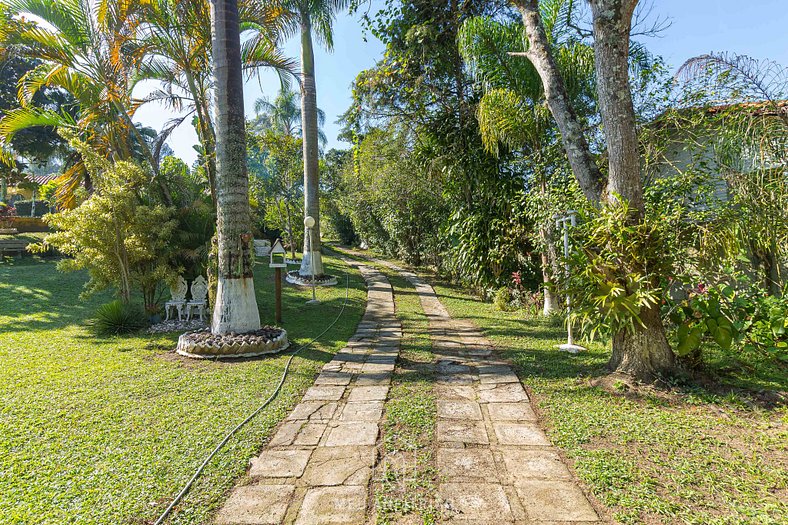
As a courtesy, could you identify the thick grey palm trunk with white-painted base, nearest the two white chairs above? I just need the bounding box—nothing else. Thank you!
[211,0,260,334]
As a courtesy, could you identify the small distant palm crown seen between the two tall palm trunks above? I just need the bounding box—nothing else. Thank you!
[252,84,327,148]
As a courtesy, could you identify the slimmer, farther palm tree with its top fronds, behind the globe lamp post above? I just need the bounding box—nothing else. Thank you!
[290,0,348,276]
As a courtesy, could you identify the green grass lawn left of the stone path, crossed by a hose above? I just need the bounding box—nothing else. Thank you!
[0,253,366,525]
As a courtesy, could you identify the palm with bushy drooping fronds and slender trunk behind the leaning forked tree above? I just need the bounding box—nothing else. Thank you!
[458,6,594,315]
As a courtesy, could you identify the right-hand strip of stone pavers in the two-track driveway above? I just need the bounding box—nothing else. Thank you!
[375,260,602,525]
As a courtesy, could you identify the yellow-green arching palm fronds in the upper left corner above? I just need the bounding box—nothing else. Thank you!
[0,0,170,205]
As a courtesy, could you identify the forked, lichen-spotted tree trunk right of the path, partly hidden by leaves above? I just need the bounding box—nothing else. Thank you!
[514,0,675,379]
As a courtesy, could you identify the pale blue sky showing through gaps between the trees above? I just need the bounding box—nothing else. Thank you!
[137,0,788,163]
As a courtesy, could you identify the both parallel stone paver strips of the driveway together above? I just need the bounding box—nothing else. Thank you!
[216,260,602,525]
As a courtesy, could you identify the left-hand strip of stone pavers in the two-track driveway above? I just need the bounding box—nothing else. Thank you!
[216,265,402,525]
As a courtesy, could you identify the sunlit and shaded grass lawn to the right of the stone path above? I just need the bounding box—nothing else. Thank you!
[435,283,788,525]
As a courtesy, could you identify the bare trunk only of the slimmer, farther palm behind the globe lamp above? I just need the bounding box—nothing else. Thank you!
[299,12,323,276]
